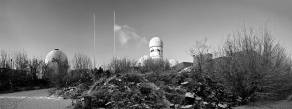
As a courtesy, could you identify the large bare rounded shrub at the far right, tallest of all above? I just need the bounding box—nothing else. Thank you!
[215,28,291,102]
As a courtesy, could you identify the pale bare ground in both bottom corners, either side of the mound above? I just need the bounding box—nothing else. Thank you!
[0,89,292,109]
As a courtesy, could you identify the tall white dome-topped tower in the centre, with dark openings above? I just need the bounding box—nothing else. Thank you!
[149,37,163,59]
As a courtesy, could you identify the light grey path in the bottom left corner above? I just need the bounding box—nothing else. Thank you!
[0,89,71,109]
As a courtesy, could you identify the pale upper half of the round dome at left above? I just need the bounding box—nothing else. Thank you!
[45,49,68,64]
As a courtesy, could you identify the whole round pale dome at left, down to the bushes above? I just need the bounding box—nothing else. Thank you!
[45,49,69,73]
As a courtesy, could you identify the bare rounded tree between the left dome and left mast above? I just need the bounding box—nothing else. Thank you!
[72,53,92,69]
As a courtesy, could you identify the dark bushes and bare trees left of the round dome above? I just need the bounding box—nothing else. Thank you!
[0,50,49,93]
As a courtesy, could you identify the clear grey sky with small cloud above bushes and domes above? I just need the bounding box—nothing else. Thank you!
[0,0,292,65]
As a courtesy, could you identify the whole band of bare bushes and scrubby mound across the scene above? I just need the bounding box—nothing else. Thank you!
[0,28,292,109]
